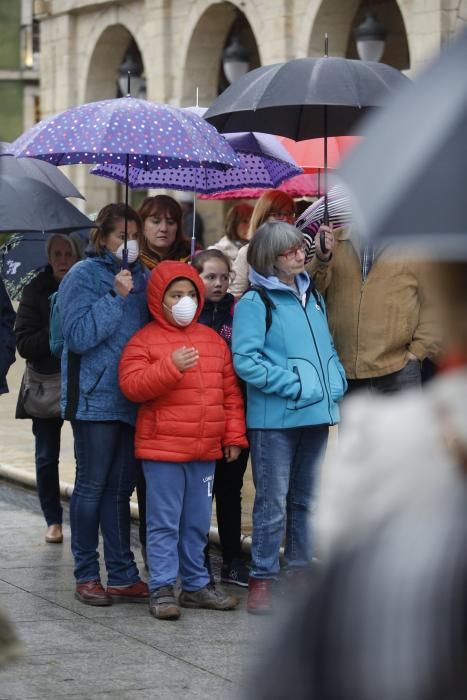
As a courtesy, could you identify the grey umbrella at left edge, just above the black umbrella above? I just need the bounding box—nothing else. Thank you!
[0,141,84,199]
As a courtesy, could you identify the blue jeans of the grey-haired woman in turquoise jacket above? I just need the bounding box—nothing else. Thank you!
[249,425,329,579]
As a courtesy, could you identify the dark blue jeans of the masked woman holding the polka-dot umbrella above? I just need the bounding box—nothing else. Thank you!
[70,420,139,586]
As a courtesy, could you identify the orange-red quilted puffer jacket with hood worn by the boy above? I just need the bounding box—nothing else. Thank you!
[119,261,248,462]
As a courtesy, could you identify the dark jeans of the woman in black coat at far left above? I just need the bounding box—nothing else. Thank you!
[32,418,63,525]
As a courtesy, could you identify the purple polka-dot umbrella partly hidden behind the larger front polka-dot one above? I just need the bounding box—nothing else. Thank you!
[91,132,303,194]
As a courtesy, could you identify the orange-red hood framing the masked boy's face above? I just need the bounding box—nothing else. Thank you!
[147,260,204,328]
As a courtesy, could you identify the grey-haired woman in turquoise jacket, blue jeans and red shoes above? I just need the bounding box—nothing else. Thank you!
[232,221,347,613]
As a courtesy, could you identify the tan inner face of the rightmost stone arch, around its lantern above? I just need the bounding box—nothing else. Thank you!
[307,0,410,70]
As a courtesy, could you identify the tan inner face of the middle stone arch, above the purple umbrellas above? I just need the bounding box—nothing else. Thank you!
[176,0,261,105]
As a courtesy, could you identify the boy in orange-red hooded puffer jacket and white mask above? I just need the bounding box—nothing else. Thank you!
[119,261,248,620]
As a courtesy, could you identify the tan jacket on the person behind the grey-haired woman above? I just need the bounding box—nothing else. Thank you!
[309,228,439,379]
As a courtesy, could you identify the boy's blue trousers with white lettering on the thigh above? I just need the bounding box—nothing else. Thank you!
[143,460,215,592]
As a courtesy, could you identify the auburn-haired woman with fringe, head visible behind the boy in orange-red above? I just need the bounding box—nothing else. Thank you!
[138,194,197,270]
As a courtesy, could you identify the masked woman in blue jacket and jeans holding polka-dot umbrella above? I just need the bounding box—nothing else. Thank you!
[58,204,148,605]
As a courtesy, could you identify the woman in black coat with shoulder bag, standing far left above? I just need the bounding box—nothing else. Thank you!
[15,233,79,544]
